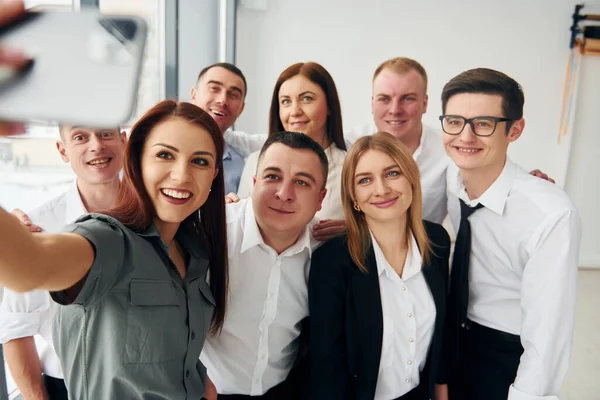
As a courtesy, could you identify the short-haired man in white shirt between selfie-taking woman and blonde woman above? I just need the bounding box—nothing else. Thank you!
[200,132,328,400]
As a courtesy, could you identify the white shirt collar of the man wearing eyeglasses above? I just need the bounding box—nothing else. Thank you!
[454,156,517,216]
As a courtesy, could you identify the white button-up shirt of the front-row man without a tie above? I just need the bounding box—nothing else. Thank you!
[200,199,319,396]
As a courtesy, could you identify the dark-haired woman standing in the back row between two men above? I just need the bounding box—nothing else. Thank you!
[228,62,346,240]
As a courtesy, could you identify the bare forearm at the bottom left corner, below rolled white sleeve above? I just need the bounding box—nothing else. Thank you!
[4,336,48,400]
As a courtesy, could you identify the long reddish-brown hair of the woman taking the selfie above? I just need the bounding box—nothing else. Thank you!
[106,100,229,334]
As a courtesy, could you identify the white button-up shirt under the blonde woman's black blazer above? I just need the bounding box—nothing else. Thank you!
[371,234,436,400]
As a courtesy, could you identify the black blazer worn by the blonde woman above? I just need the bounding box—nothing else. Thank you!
[307,221,450,400]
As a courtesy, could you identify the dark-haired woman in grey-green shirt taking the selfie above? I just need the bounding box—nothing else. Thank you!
[0,101,228,400]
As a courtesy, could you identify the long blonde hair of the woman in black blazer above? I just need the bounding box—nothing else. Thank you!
[342,132,431,273]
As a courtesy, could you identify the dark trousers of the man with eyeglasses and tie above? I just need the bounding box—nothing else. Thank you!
[449,321,523,400]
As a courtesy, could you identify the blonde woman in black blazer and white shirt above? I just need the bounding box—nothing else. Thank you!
[309,132,450,400]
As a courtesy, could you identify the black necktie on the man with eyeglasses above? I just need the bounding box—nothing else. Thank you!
[448,199,483,327]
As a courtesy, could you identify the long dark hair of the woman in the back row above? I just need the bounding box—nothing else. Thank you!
[269,62,346,150]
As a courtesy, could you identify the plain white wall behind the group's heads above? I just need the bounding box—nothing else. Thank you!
[236,0,600,264]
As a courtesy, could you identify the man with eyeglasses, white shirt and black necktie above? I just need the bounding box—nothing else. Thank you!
[440,68,581,400]
